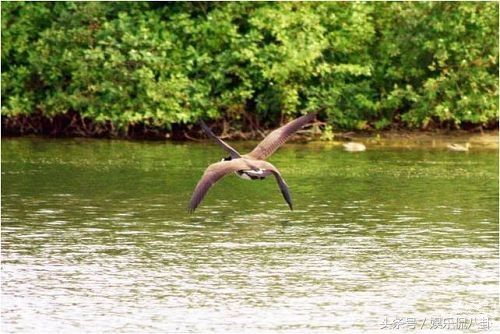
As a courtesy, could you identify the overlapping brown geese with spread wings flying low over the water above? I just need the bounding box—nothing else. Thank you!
[188,113,316,212]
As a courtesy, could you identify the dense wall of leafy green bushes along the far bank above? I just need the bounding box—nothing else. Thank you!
[2,2,498,134]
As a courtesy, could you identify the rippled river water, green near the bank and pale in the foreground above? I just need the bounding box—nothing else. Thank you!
[1,139,499,333]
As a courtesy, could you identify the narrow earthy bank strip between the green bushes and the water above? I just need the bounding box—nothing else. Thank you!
[2,113,498,148]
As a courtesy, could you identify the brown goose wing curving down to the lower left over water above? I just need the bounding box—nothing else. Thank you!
[188,159,251,212]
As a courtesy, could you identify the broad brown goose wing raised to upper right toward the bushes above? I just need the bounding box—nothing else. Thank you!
[247,113,316,160]
